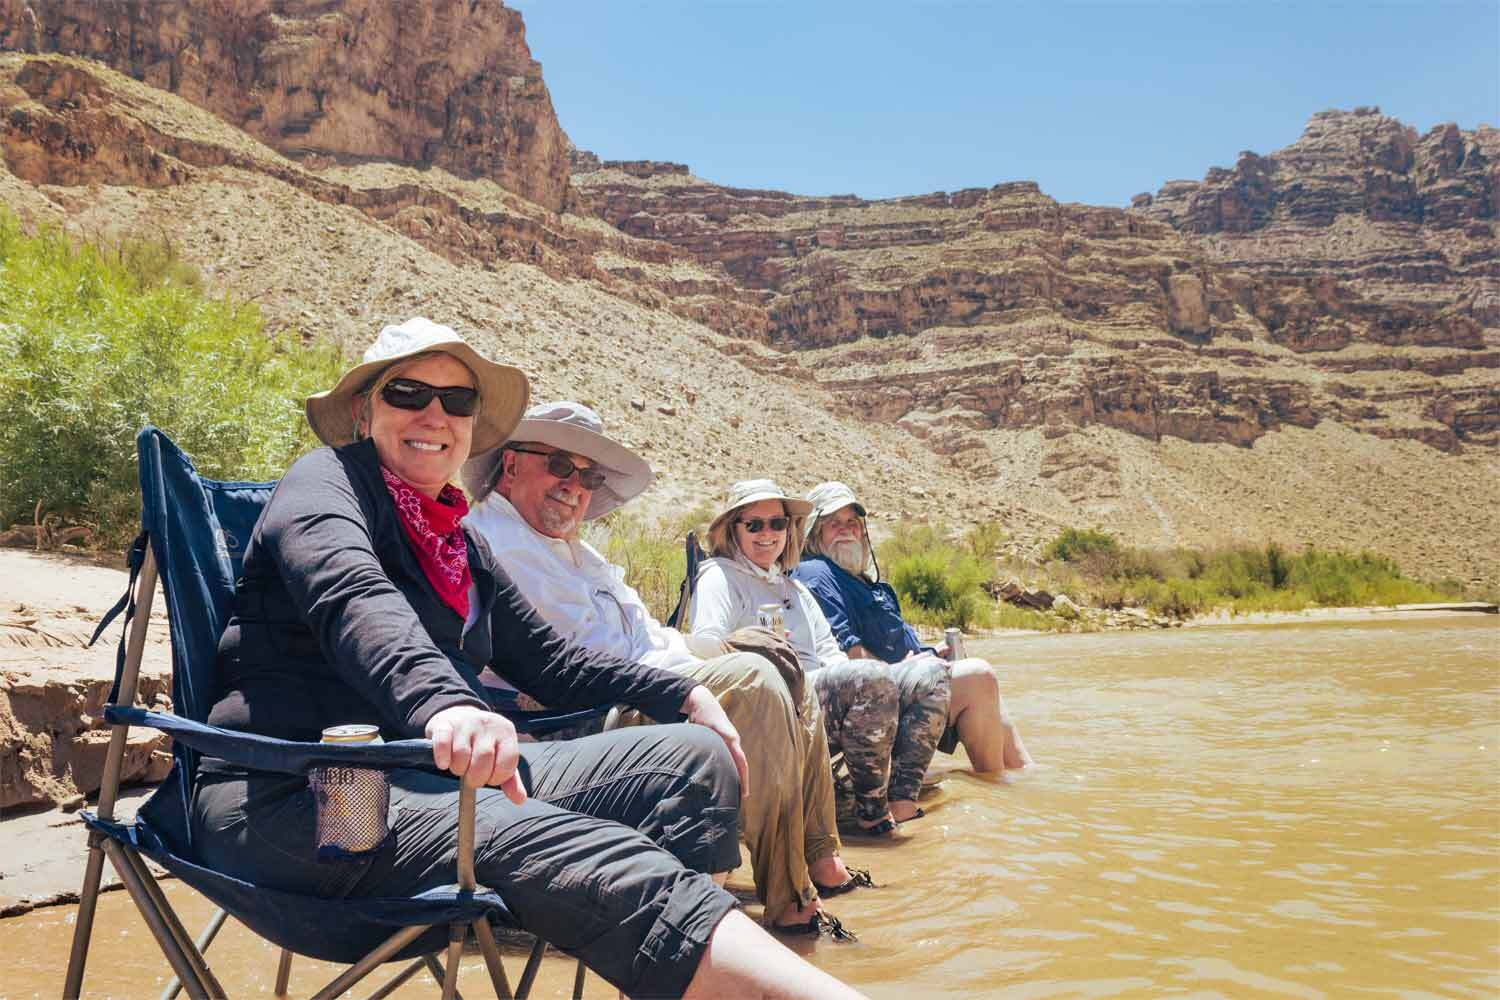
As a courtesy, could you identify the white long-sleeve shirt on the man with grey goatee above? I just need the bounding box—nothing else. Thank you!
[464,493,698,680]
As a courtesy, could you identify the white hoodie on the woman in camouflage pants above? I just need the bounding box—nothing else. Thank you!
[693,556,849,672]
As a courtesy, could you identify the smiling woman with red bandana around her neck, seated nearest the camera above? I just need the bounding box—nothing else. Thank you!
[192,319,837,996]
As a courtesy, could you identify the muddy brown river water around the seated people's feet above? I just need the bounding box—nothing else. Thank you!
[0,615,1500,1000]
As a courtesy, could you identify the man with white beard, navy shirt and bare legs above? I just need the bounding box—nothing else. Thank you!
[792,483,1032,772]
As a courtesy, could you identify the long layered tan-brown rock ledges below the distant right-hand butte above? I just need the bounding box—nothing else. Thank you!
[575,137,1500,453]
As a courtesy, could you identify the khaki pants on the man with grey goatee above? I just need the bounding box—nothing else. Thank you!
[623,652,839,919]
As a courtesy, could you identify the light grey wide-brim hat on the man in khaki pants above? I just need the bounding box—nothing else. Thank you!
[462,400,656,520]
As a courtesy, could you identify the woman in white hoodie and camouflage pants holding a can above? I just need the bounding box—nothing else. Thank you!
[692,480,950,835]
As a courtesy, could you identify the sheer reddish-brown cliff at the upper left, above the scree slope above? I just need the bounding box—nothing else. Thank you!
[0,0,569,211]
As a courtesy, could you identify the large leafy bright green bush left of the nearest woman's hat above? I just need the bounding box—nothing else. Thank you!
[0,210,342,546]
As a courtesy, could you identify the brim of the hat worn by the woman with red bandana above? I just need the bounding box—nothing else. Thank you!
[306,340,531,454]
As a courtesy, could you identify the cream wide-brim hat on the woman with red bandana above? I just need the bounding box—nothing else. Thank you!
[308,316,531,454]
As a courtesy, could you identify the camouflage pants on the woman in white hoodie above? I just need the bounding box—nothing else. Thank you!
[812,655,951,823]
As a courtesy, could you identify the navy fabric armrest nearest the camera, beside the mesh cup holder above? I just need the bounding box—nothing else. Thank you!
[104,705,437,774]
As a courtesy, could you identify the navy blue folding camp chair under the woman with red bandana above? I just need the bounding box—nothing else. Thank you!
[63,427,596,1000]
